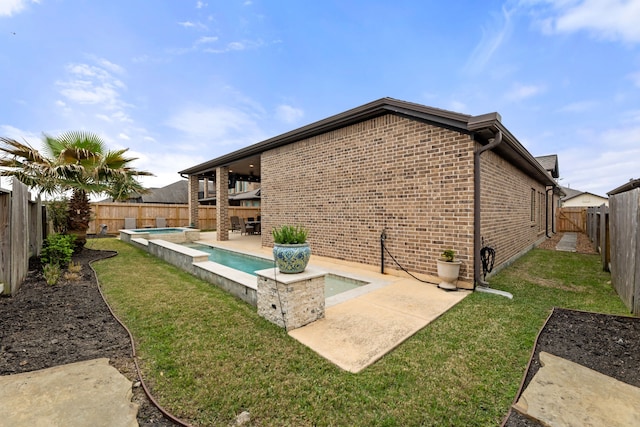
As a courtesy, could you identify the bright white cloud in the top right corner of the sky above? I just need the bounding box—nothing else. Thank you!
[526,0,640,43]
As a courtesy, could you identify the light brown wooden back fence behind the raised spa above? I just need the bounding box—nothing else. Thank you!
[88,203,260,234]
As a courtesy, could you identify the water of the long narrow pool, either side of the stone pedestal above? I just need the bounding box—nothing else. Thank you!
[183,243,368,297]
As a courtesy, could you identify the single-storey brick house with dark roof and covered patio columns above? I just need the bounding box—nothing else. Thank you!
[180,98,559,288]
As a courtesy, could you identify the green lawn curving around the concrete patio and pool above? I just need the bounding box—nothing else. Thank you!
[87,239,628,426]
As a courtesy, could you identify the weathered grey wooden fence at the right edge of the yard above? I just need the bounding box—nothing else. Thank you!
[604,188,640,315]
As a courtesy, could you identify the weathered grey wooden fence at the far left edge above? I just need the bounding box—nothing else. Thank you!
[0,178,43,295]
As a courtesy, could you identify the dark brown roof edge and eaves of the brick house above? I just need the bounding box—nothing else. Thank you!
[179,98,555,185]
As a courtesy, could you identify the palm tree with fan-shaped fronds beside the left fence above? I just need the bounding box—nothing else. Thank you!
[0,131,153,247]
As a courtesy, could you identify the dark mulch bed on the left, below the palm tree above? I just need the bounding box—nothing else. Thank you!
[0,248,176,427]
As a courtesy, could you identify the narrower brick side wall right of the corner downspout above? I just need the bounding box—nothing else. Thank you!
[480,147,551,266]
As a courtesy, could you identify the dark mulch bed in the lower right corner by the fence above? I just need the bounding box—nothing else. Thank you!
[503,308,640,427]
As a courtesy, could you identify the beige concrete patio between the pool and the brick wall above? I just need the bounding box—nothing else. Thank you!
[200,232,470,373]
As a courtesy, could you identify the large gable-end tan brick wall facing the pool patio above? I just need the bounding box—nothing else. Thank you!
[261,114,476,281]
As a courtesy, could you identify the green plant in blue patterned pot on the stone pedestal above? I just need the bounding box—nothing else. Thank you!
[271,225,311,274]
